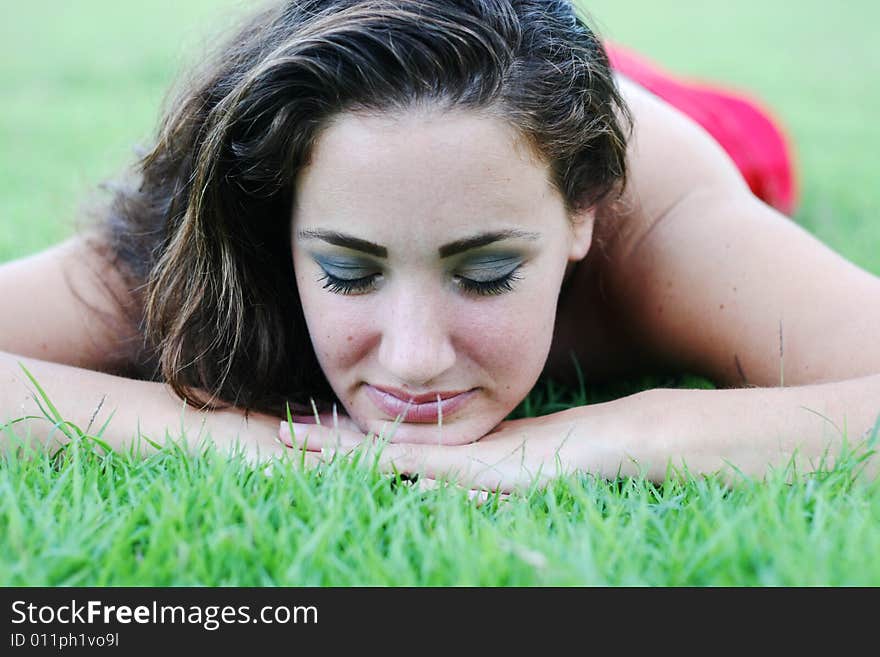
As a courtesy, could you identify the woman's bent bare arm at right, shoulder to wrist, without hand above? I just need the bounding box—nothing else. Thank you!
[575,78,880,478]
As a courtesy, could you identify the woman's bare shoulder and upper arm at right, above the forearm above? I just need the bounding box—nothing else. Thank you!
[590,74,880,386]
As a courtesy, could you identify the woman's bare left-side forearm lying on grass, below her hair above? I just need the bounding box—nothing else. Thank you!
[0,352,274,454]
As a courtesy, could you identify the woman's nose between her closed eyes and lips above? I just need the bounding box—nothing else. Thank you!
[378,288,456,388]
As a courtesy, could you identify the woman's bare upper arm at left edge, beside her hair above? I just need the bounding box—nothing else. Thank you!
[0,235,138,373]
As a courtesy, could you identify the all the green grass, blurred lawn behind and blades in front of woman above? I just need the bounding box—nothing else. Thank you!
[0,0,880,586]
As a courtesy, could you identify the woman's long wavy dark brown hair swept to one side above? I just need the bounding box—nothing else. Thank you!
[103,0,631,413]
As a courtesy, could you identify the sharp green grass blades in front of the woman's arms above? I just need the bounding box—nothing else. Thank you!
[6,404,880,586]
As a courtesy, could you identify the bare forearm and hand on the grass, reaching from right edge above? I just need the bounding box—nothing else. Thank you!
[282,376,880,492]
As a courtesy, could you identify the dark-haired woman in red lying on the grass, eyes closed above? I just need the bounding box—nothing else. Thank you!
[0,0,880,490]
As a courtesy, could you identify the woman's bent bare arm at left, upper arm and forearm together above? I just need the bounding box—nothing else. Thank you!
[0,237,296,457]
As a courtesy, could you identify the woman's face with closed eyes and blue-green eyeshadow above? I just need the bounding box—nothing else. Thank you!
[292,111,592,444]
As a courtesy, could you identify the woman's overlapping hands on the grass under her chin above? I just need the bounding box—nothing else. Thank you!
[279,405,619,492]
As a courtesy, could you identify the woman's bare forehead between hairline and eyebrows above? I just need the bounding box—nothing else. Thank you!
[294,110,562,237]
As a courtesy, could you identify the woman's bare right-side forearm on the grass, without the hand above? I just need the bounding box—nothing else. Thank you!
[605,375,880,480]
